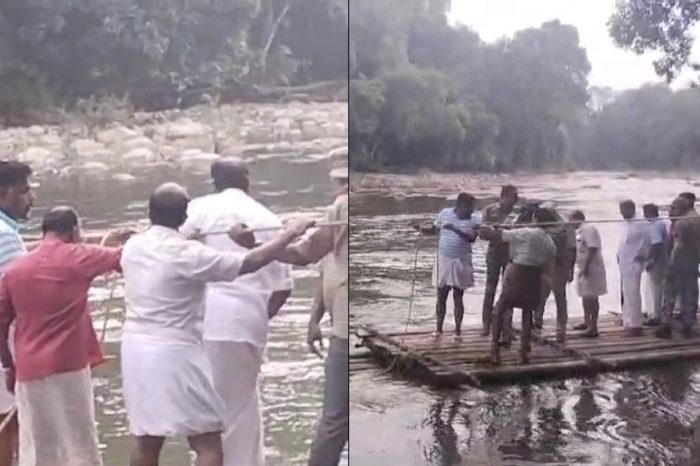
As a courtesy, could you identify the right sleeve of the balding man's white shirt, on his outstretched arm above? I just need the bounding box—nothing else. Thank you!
[173,241,245,283]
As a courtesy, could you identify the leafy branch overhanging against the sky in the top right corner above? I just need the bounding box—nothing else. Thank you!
[608,0,700,82]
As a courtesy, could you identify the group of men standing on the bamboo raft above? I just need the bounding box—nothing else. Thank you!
[420,185,700,363]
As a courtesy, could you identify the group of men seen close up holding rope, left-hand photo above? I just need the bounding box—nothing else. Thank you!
[0,158,348,466]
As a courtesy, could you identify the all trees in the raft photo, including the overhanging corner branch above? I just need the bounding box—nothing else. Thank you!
[349,0,700,172]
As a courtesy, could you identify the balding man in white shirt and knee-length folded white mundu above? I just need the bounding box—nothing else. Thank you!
[121,183,314,466]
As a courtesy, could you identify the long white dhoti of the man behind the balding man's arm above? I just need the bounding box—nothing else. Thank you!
[204,340,265,466]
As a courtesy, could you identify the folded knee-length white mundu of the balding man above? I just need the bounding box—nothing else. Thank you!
[121,333,224,437]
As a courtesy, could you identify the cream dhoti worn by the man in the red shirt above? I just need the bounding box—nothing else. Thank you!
[15,368,102,466]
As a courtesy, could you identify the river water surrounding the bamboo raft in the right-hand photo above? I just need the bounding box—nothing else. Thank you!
[350,173,700,466]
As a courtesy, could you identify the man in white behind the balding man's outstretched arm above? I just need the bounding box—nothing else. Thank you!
[180,158,293,466]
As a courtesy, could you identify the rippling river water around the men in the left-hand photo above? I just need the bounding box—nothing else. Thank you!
[29,154,347,466]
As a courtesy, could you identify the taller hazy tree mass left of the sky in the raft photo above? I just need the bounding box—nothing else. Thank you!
[350,0,590,170]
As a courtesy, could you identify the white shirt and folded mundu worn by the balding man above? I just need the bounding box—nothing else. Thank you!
[121,226,244,437]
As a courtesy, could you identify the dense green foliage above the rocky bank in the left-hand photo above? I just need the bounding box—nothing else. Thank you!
[0,0,348,116]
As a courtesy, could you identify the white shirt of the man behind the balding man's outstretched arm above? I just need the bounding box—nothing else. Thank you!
[180,188,294,348]
